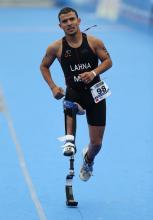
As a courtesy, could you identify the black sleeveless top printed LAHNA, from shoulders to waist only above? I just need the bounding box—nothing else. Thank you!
[61,33,100,89]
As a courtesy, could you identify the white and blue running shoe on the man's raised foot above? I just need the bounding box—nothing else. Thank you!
[79,148,94,181]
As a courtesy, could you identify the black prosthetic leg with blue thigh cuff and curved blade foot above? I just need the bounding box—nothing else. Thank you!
[64,101,78,207]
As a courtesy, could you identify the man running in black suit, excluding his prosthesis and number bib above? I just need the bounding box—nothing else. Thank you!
[40,7,112,181]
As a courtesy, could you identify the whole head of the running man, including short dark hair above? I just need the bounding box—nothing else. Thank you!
[58,7,80,35]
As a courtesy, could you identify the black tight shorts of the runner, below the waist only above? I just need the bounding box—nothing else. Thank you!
[65,88,106,126]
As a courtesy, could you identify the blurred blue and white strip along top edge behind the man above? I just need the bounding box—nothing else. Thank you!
[0,0,153,29]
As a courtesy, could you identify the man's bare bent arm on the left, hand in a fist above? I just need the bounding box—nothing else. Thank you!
[40,42,64,99]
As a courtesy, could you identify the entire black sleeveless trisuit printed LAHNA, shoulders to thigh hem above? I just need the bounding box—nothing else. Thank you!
[61,33,106,126]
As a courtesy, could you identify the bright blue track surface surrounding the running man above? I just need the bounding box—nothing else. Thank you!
[0,8,153,220]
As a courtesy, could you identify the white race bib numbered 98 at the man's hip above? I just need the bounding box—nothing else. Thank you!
[90,81,111,103]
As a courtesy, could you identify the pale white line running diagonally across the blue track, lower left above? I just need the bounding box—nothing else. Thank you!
[0,88,47,220]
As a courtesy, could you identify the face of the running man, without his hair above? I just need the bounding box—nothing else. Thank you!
[59,12,80,35]
